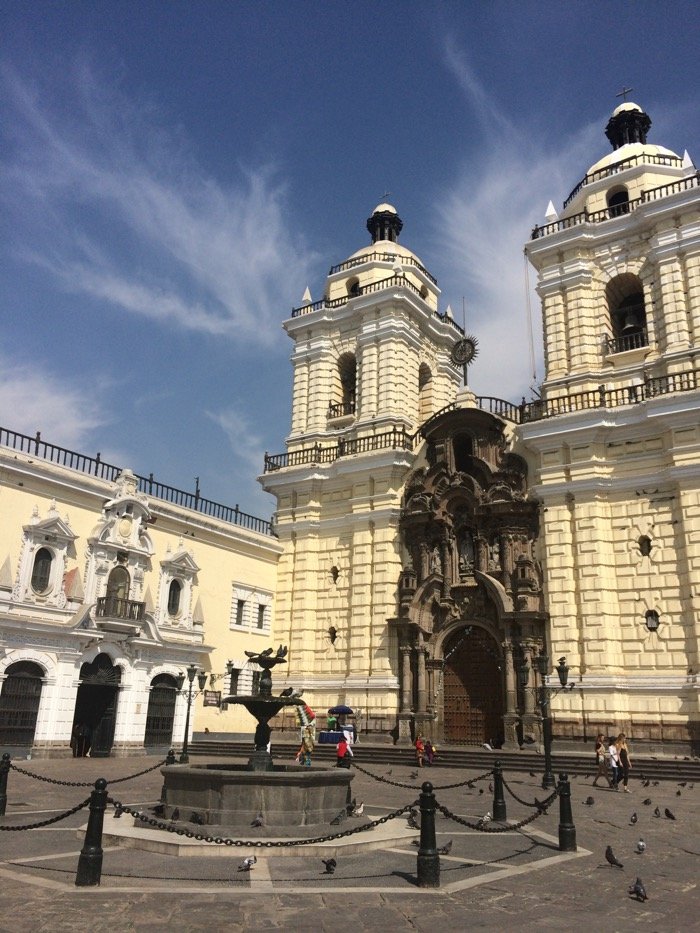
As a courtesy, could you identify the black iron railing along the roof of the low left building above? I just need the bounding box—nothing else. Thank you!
[0,428,272,535]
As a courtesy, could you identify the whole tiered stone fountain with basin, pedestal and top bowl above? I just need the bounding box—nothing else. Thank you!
[162,645,353,838]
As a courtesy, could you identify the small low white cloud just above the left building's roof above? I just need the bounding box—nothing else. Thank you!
[0,357,110,450]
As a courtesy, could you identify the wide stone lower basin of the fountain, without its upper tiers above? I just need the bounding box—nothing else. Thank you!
[161,763,353,835]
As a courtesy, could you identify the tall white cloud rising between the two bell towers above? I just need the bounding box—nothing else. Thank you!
[434,42,602,401]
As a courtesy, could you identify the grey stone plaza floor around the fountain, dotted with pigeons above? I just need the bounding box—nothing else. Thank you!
[0,748,700,933]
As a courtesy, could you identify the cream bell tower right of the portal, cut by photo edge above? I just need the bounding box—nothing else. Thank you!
[518,101,700,751]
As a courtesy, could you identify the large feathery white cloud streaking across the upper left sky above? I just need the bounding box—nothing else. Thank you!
[3,67,313,344]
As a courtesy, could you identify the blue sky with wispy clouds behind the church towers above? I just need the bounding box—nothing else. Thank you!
[0,0,700,516]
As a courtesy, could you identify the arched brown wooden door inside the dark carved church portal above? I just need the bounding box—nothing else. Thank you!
[443,626,503,745]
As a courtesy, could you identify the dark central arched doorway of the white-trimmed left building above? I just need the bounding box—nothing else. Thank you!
[72,654,121,758]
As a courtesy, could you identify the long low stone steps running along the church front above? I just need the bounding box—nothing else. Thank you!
[182,737,700,783]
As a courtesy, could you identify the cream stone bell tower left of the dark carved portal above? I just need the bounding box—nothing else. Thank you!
[261,203,463,730]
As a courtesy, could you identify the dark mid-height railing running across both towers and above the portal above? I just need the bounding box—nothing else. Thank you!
[264,369,700,473]
